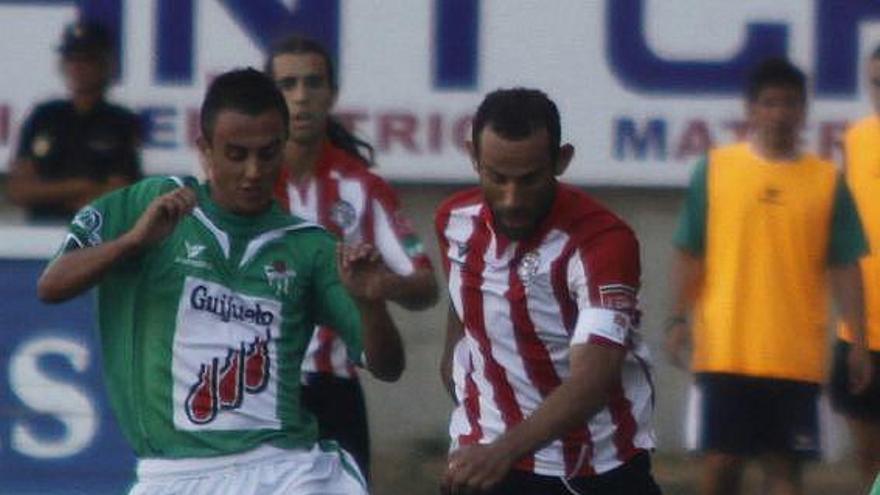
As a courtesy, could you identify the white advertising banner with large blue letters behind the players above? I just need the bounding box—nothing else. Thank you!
[0,0,880,186]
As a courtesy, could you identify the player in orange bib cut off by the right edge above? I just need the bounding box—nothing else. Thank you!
[830,47,880,493]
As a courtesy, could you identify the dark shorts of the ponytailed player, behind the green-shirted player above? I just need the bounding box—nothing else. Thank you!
[302,373,370,481]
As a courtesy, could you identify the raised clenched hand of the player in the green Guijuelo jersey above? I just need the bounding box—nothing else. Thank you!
[126,187,197,248]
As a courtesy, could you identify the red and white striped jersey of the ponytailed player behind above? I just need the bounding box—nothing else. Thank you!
[275,141,430,378]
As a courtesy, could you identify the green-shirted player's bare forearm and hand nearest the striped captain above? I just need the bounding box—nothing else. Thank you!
[337,244,406,382]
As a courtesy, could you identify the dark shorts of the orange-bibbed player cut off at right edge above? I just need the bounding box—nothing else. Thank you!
[829,340,880,421]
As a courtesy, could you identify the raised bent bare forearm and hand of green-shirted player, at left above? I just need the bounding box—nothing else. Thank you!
[37,188,196,303]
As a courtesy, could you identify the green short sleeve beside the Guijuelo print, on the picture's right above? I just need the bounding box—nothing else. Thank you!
[313,233,364,365]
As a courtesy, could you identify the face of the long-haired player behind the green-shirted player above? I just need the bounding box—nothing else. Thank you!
[272,53,336,144]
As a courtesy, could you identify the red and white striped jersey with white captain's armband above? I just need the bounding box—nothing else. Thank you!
[436,185,654,477]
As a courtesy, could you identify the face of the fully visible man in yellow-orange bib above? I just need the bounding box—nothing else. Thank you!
[748,86,807,152]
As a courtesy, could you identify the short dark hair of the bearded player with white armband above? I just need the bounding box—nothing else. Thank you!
[471,88,562,160]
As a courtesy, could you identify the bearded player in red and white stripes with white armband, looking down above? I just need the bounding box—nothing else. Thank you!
[436,88,660,495]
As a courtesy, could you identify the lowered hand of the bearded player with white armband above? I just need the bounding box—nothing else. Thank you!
[441,443,515,495]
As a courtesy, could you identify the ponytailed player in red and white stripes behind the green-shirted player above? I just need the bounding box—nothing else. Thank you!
[266,36,437,484]
